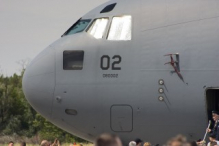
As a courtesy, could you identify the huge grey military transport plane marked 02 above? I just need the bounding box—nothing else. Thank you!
[23,0,219,144]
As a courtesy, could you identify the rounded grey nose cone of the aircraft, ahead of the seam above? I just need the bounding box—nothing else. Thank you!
[22,47,55,118]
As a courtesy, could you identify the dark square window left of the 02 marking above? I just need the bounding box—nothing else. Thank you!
[63,50,84,70]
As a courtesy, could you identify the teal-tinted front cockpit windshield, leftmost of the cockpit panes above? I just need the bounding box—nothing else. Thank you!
[64,19,91,35]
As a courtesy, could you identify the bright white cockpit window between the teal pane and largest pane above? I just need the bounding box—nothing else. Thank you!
[87,18,109,39]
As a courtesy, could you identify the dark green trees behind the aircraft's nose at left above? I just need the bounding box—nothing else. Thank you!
[0,70,85,142]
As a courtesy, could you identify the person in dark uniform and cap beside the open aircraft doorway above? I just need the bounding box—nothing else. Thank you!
[207,111,219,141]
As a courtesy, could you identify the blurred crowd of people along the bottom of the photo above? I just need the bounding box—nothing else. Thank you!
[8,111,219,146]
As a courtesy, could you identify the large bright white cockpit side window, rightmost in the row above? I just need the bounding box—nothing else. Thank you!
[107,15,132,40]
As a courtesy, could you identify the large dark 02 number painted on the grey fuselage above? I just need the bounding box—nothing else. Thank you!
[100,55,122,70]
